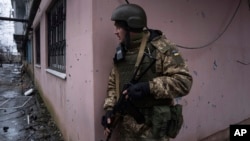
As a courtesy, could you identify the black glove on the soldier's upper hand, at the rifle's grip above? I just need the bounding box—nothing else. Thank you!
[127,82,150,100]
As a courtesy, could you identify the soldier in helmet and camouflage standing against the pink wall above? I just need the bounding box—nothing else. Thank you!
[102,4,192,141]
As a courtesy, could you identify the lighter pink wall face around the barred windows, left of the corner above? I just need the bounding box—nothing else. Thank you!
[33,0,95,141]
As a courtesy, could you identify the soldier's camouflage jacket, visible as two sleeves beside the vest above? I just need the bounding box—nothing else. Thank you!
[104,30,193,110]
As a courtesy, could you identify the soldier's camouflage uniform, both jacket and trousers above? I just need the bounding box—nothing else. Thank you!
[104,29,192,141]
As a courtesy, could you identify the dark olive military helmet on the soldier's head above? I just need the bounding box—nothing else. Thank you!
[111,4,147,28]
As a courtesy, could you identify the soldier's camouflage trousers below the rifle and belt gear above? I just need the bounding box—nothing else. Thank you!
[119,116,169,141]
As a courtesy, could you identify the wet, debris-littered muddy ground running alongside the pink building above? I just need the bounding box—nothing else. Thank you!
[0,64,63,141]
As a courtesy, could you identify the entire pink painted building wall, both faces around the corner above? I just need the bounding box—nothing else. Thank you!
[33,0,250,141]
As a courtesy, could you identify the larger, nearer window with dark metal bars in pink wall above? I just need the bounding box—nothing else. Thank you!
[48,0,66,73]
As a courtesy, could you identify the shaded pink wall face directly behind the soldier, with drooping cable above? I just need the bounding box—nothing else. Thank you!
[94,0,250,141]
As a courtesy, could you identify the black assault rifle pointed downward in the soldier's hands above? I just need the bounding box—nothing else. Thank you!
[106,53,156,141]
